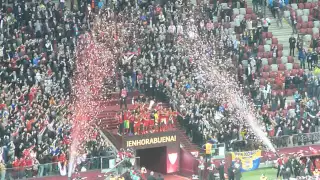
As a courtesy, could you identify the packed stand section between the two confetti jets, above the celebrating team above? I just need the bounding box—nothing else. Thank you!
[105,1,262,150]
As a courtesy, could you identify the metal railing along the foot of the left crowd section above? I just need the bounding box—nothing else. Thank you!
[0,156,116,180]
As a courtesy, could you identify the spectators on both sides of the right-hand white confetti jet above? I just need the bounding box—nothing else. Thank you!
[112,2,319,153]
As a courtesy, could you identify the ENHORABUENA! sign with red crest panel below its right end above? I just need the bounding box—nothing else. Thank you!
[122,131,180,173]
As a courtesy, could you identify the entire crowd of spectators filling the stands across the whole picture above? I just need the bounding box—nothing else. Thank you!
[0,0,319,178]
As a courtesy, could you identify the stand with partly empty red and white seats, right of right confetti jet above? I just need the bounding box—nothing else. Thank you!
[232,0,319,152]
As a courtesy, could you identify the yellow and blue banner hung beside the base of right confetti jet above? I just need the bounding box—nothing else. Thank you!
[231,150,261,172]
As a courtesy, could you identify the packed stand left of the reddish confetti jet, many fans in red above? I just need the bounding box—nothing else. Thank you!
[0,1,114,179]
